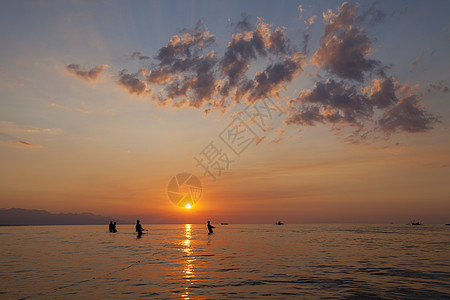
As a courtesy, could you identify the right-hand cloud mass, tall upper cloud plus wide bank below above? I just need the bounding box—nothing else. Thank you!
[286,2,443,141]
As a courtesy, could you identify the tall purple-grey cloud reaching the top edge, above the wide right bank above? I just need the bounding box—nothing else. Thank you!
[312,2,380,82]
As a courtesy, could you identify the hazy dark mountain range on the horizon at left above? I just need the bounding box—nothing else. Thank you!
[0,208,131,226]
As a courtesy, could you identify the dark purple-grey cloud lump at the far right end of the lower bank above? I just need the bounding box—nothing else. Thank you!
[378,95,438,134]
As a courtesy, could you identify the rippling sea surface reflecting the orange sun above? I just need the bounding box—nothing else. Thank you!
[0,224,450,299]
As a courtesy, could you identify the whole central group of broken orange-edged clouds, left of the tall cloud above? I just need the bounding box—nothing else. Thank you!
[137,14,304,112]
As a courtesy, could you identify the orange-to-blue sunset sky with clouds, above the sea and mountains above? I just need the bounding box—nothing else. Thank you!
[0,0,450,223]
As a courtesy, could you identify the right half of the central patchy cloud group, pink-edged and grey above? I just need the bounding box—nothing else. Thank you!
[219,18,303,102]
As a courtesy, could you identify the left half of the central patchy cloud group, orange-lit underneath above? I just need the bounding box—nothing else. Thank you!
[142,22,217,108]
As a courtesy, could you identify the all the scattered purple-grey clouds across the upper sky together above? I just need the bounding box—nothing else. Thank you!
[67,2,440,139]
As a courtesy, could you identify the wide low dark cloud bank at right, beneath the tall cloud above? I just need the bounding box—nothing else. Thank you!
[286,78,439,139]
